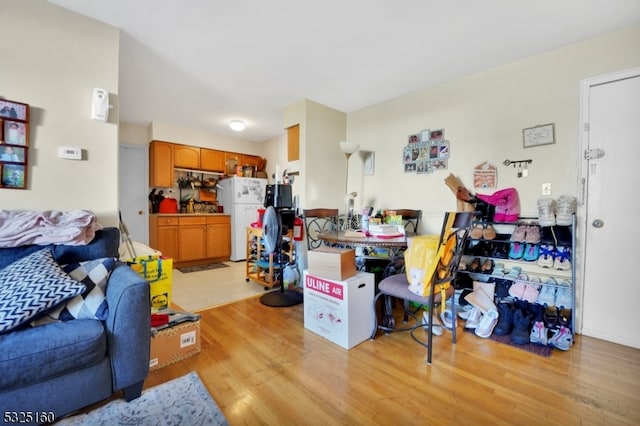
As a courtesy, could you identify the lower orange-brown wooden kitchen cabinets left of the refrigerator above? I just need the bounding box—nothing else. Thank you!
[149,214,231,267]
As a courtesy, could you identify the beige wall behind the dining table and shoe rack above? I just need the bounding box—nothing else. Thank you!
[347,26,640,231]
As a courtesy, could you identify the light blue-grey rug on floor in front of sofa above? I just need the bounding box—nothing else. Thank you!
[57,371,229,426]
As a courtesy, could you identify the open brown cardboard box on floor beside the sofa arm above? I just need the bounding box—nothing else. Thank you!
[149,319,202,371]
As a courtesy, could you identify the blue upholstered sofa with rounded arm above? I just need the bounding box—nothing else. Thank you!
[0,228,150,423]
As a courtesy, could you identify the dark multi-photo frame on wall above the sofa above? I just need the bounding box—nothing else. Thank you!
[0,99,29,189]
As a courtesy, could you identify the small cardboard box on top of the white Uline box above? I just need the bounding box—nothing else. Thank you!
[307,246,358,281]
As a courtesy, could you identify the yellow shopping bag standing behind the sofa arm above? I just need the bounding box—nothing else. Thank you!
[127,255,173,309]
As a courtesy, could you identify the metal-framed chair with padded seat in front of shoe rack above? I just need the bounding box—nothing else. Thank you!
[371,212,474,364]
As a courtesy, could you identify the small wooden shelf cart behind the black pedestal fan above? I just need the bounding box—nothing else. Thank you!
[245,227,294,290]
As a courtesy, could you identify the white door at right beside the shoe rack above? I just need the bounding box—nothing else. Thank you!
[577,70,640,348]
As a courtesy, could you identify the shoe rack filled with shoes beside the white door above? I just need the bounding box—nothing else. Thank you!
[459,214,575,350]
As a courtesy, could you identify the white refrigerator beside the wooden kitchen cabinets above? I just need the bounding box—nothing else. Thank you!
[217,176,267,262]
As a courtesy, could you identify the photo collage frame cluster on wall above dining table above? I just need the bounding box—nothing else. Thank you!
[402,129,450,174]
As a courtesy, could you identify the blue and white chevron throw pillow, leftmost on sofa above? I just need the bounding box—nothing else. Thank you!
[0,248,86,333]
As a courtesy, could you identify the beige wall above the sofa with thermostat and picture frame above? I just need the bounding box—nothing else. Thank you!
[0,0,119,225]
